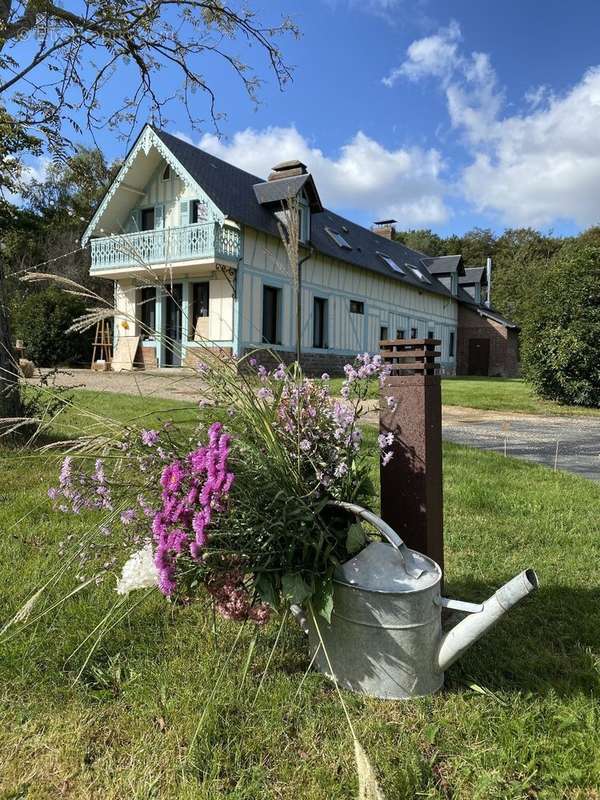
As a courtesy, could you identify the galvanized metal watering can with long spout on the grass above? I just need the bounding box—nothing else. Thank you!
[292,503,538,700]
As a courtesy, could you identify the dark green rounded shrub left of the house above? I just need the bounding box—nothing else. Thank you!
[15,288,93,367]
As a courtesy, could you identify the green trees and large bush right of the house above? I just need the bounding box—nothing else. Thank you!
[396,226,600,407]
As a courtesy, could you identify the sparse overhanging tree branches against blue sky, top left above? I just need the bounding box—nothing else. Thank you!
[0,0,297,155]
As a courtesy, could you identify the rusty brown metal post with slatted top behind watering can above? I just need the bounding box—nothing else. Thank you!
[379,339,444,569]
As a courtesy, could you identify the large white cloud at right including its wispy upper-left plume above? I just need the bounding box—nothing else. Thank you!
[383,23,600,226]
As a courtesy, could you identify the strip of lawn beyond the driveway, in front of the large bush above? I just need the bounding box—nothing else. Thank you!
[331,377,600,416]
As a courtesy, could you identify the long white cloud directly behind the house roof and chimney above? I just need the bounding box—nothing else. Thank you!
[192,126,449,226]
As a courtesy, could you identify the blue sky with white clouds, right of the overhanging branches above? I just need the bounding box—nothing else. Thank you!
[14,0,600,234]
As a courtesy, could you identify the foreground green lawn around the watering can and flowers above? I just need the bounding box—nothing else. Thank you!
[0,393,600,800]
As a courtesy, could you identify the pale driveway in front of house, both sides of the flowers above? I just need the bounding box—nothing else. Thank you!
[23,370,600,481]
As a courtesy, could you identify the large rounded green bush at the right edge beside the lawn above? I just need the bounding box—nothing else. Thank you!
[522,242,600,408]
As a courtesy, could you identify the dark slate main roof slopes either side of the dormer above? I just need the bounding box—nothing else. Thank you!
[153,128,460,297]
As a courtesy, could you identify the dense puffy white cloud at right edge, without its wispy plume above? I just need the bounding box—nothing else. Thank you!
[463,67,600,227]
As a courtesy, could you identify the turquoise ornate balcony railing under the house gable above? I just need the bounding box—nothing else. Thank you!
[90,222,242,272]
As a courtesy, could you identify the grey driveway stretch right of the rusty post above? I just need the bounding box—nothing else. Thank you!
[442,406,600,481]
